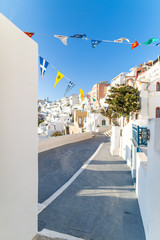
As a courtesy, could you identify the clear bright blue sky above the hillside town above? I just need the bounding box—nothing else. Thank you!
[0,0,160,100]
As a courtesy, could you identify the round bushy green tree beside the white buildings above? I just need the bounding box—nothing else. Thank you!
[105,85,140,122]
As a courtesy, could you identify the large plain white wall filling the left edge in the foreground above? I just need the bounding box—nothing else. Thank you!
[0,14,38,240]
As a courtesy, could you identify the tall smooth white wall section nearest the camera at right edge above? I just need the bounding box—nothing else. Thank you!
[146,118,160,240]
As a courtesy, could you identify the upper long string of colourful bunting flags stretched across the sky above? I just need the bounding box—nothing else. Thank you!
[24,32,160,49]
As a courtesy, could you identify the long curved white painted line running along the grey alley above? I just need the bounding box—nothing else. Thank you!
[38,143,104,214]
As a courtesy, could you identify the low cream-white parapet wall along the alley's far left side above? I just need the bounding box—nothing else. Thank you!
[38,132,92,153]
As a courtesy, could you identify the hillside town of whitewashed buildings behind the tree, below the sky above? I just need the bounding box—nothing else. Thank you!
[38,57,160,140]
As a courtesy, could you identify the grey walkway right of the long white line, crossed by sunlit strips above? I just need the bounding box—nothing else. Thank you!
[39,139,145,240]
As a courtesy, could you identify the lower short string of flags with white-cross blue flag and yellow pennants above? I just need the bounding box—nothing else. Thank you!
[39,56,84,102]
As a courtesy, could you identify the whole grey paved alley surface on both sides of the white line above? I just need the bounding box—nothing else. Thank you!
[39,134,145,240]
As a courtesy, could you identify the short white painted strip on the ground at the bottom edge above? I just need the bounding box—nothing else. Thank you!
[38,228,85,240]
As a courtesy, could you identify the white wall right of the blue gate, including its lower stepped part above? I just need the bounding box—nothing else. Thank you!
[136,119,160,240]
